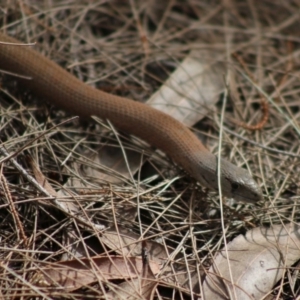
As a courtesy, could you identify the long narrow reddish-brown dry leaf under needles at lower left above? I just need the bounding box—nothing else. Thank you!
[32,256,159,292]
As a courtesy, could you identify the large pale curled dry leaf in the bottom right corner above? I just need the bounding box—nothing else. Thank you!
[203,223,300,300]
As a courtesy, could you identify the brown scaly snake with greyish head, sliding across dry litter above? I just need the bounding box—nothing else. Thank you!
[0,33,262,203]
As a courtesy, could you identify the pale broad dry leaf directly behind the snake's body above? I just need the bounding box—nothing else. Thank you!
[147,50,225,126]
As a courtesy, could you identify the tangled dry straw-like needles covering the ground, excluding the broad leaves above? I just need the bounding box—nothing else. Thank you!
[0,0,300,299]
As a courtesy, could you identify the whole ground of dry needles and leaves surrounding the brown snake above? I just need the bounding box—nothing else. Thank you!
[0,0,300,299]
